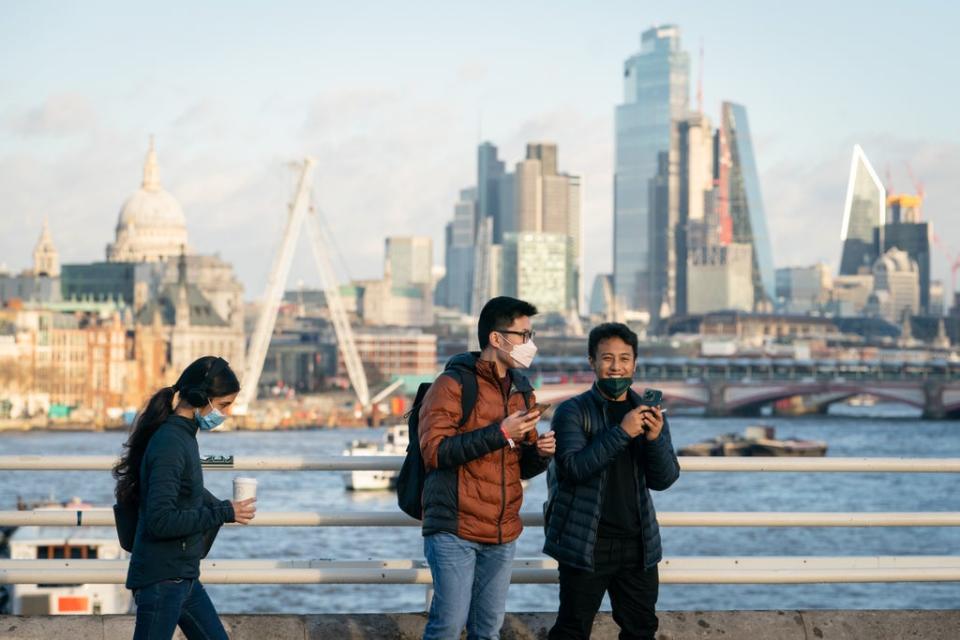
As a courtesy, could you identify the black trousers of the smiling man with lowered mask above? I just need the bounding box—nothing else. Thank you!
[547,538,660,640]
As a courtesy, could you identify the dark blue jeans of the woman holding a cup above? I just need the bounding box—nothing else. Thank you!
[133,578,228,640]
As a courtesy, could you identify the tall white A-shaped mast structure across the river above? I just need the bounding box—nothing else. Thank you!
[233,158,374,415]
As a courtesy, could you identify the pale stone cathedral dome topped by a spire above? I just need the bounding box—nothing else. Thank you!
[107,140,187,262]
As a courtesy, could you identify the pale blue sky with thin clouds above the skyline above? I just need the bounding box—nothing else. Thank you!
[0,0,960,299]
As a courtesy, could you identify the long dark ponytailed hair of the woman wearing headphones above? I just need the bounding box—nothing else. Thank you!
[113,356,240,506]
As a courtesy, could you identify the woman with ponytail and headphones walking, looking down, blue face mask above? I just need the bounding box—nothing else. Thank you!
[113,356,256,640]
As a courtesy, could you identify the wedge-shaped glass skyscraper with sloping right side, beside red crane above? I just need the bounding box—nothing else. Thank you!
[721,102,776,305]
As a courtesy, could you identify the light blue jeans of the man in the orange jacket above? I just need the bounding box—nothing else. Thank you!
[423,533,516,640]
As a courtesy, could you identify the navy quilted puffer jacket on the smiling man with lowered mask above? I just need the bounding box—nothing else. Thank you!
[543,385,680,570]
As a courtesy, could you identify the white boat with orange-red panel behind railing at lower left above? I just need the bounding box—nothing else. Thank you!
[8,499,133,616]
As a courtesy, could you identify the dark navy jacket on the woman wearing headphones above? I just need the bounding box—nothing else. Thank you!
[127,415,234,589]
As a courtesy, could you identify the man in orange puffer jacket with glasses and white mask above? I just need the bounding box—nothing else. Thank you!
[419,296,555,640]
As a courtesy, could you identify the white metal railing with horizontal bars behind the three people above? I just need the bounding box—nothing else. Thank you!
[0,455,960,585]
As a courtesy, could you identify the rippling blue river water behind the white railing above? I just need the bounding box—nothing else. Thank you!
[0,405,960,613]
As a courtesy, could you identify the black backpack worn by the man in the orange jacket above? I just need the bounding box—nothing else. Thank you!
[397,368,478,520]
